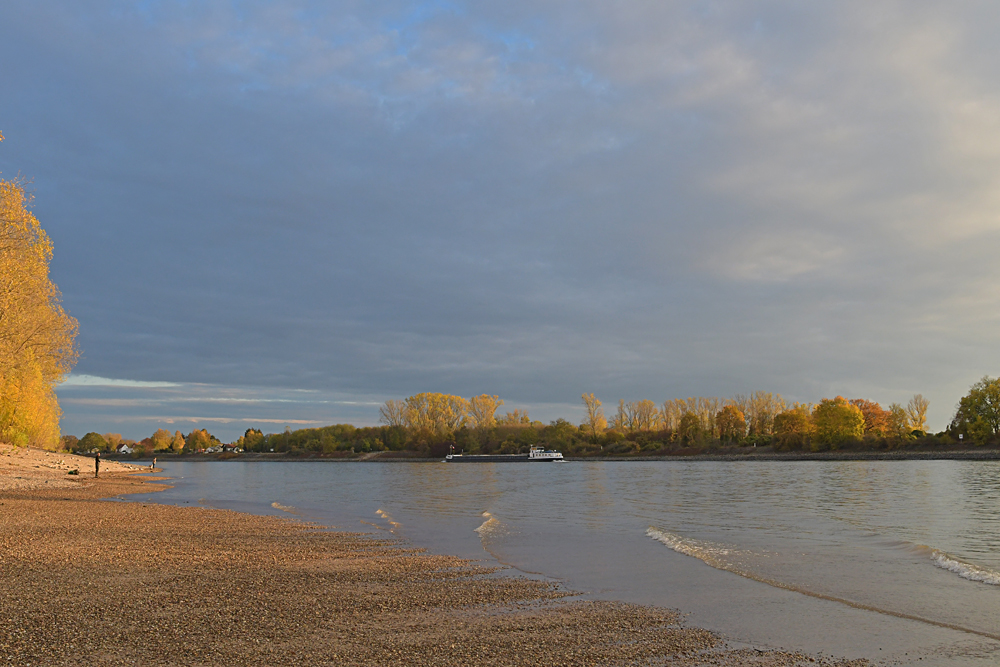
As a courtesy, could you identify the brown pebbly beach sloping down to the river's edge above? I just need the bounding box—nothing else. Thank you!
[0,450,869,667]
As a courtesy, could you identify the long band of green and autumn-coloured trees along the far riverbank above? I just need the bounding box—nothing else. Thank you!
[70,377,1000,458]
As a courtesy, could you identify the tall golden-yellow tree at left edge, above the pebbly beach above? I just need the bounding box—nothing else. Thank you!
[0,145,78,447]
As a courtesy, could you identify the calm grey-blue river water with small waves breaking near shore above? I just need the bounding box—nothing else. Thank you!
[129,461,1000,665]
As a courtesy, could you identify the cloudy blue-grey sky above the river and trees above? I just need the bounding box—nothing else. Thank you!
[0,0,1000,440]
